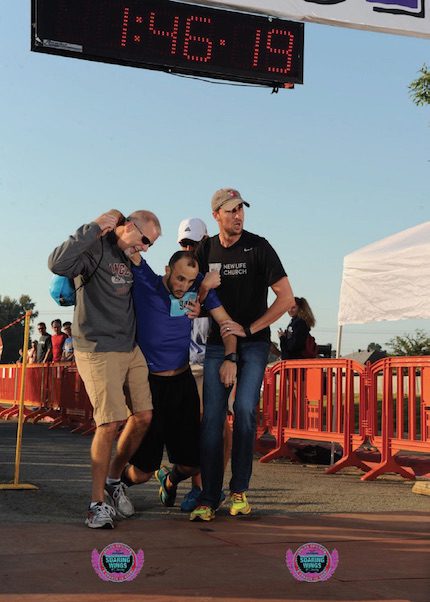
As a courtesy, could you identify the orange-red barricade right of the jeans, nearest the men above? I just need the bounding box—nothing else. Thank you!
[260,359,368,470]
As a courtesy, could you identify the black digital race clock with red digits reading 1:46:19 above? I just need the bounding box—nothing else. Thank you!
[31,0,304,87]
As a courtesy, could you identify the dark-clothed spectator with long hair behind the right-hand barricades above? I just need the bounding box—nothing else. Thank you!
[278,297,316,360]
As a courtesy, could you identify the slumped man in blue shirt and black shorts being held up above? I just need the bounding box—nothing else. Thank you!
[122,251,236,506]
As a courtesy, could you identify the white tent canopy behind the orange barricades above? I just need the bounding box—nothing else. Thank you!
[338,222,430,326]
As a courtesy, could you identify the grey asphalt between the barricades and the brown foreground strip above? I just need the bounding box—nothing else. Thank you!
[0,422,430,523]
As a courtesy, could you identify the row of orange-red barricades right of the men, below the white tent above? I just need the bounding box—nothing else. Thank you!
[257,357,430,480]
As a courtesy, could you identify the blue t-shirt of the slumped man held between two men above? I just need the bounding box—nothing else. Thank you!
[132,259,221,372]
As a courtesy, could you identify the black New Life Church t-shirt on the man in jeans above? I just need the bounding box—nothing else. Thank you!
[197,230,286,345]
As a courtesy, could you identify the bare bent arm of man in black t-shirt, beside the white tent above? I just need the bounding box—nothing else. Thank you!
[221,276,295,337]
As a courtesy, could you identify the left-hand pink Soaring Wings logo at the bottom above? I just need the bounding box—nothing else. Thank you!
[91,543,144,583]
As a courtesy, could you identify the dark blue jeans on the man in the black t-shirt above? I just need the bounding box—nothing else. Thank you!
[200,341,269,508]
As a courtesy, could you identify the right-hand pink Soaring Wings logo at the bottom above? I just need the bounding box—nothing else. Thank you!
[285,543,339,582]
